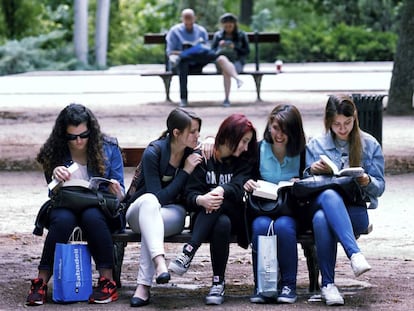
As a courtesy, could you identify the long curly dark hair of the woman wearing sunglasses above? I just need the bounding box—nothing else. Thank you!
[36,103,105,176]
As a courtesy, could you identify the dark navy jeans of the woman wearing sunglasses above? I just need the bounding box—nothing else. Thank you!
[38,208,114,272]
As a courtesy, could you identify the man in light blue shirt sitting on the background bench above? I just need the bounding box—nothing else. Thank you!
[166,9,216,107]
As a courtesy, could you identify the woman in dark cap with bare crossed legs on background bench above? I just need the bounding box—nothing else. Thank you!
[211,13,250,107]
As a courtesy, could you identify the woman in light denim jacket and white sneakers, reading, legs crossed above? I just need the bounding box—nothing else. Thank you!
[305,95,385,305]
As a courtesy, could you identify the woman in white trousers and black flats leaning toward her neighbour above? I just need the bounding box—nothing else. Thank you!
[126,108,202,307]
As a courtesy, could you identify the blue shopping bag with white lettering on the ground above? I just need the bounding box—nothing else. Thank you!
[52,227,92,303]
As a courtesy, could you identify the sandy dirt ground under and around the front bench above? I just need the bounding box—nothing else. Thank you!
[0,172,414,310]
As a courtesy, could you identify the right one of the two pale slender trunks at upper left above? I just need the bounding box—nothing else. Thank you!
[95,0,110,67]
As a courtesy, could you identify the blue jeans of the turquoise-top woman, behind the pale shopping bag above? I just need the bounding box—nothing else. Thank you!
[252,216,298,290]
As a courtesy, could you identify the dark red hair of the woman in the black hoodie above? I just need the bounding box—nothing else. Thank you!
[214,113,257,159]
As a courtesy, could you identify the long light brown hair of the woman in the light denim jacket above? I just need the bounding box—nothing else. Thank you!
[324,94,362,167]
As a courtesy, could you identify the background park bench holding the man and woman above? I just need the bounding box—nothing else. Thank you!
[141,32,280,102]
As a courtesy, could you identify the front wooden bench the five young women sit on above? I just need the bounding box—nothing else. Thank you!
[112,147,373,293]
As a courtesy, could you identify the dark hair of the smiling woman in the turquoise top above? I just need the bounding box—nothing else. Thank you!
[263,104,306,157]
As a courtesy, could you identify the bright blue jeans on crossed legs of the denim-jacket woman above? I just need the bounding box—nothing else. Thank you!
[312,190,369,286]
